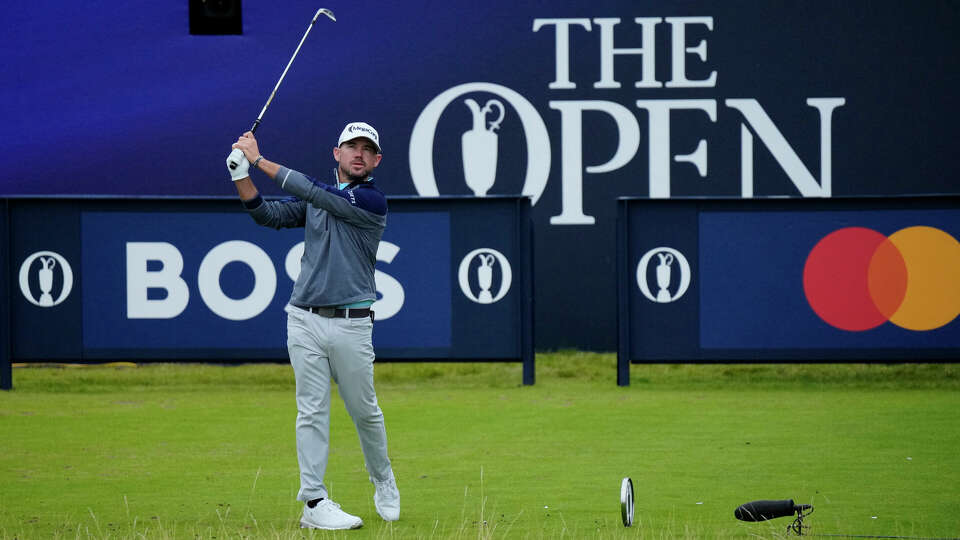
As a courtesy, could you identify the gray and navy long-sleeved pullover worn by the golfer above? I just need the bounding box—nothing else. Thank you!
[243,167,387,307]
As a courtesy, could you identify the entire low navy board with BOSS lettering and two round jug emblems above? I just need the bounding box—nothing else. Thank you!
[4,196,533,384]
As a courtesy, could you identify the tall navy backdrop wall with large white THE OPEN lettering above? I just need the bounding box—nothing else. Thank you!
[0,0,960,351]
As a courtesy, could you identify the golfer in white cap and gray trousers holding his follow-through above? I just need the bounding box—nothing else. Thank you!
[228,122,400,529]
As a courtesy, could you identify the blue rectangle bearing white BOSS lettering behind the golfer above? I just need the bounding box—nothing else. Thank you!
[81,211,442,349]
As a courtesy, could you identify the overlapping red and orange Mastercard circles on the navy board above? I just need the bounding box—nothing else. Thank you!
[803,226,960,332]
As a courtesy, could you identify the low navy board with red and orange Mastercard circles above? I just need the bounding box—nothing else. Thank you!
[618,197,960,381]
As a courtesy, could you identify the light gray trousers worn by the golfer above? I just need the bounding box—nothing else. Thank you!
[286,305,393,501]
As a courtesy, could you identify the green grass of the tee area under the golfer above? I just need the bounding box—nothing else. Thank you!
[0,352,960,538]
